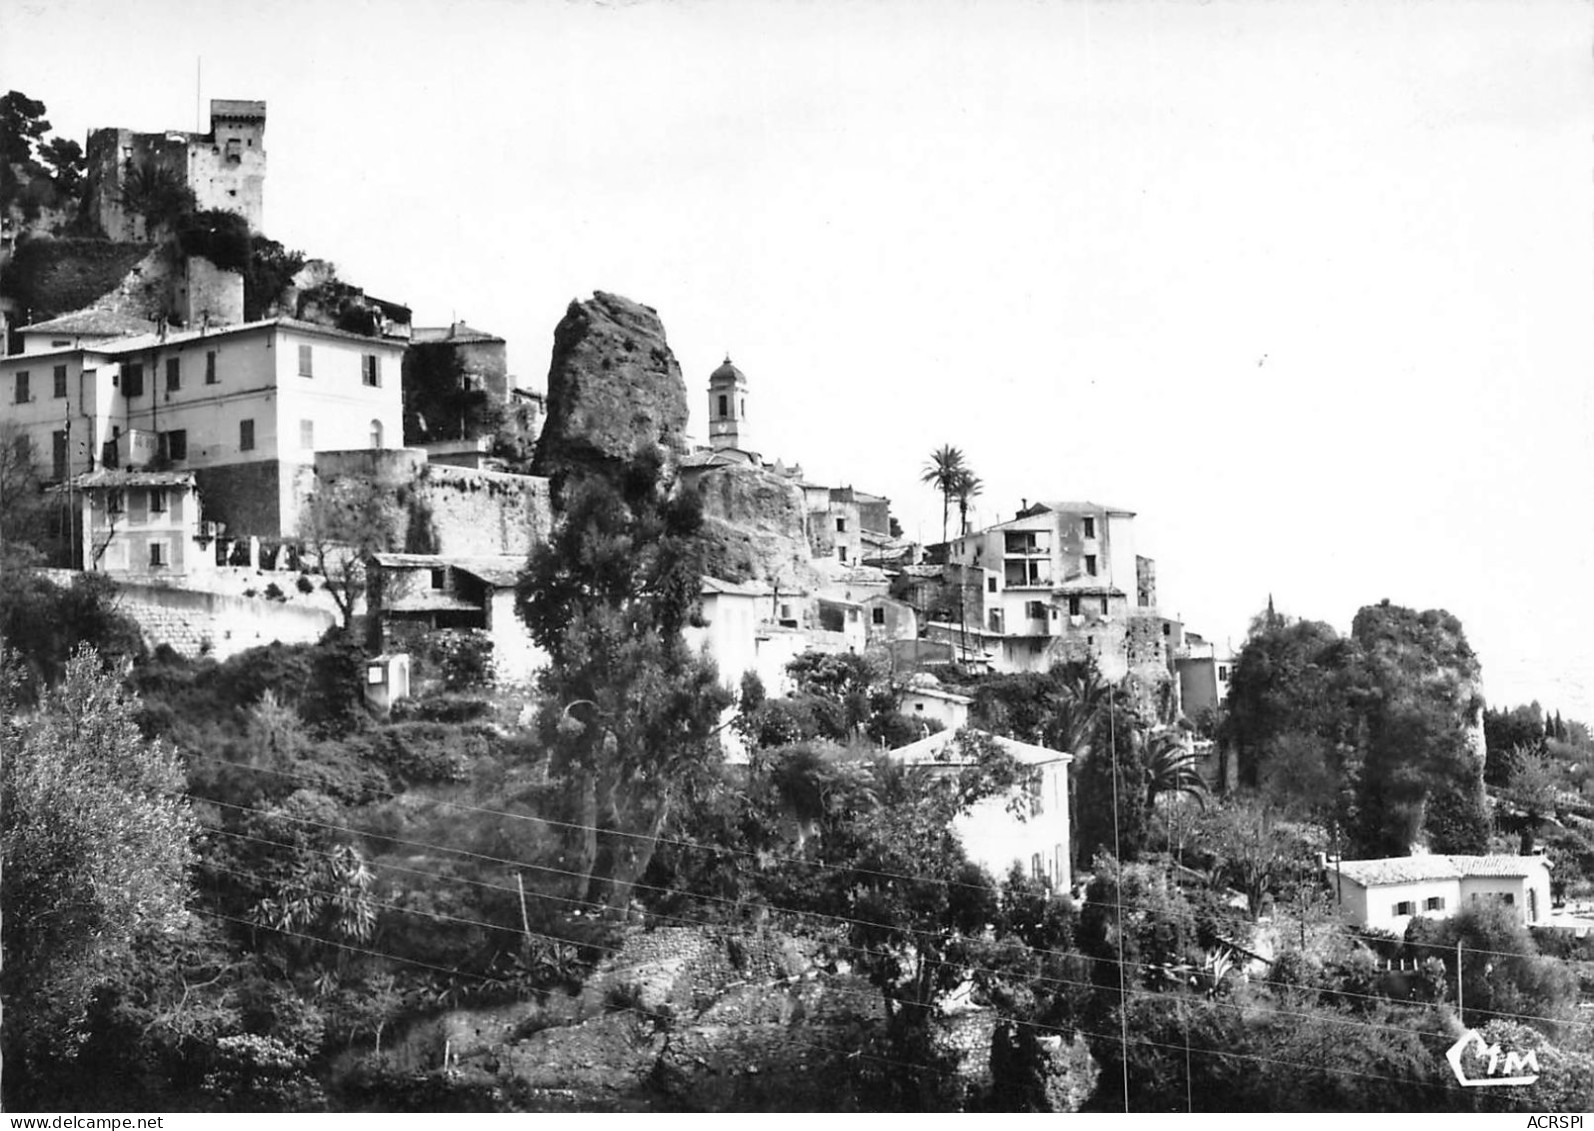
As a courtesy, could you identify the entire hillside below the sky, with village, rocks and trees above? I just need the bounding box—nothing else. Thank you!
[9,92,1594,1112]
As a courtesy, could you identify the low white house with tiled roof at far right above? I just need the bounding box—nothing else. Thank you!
[1323,855,1549,933]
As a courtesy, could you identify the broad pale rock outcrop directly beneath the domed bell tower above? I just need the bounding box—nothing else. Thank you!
[687,465,819,591]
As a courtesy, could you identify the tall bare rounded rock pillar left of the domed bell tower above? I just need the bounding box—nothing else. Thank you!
[532,292,687,489]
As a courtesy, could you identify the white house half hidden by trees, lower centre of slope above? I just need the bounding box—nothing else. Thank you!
[886,730,1074,892]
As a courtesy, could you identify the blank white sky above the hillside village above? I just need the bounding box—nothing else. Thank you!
[0,0,1594,722]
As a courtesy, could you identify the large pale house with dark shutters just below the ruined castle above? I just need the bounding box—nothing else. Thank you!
[0,319,405,540]
